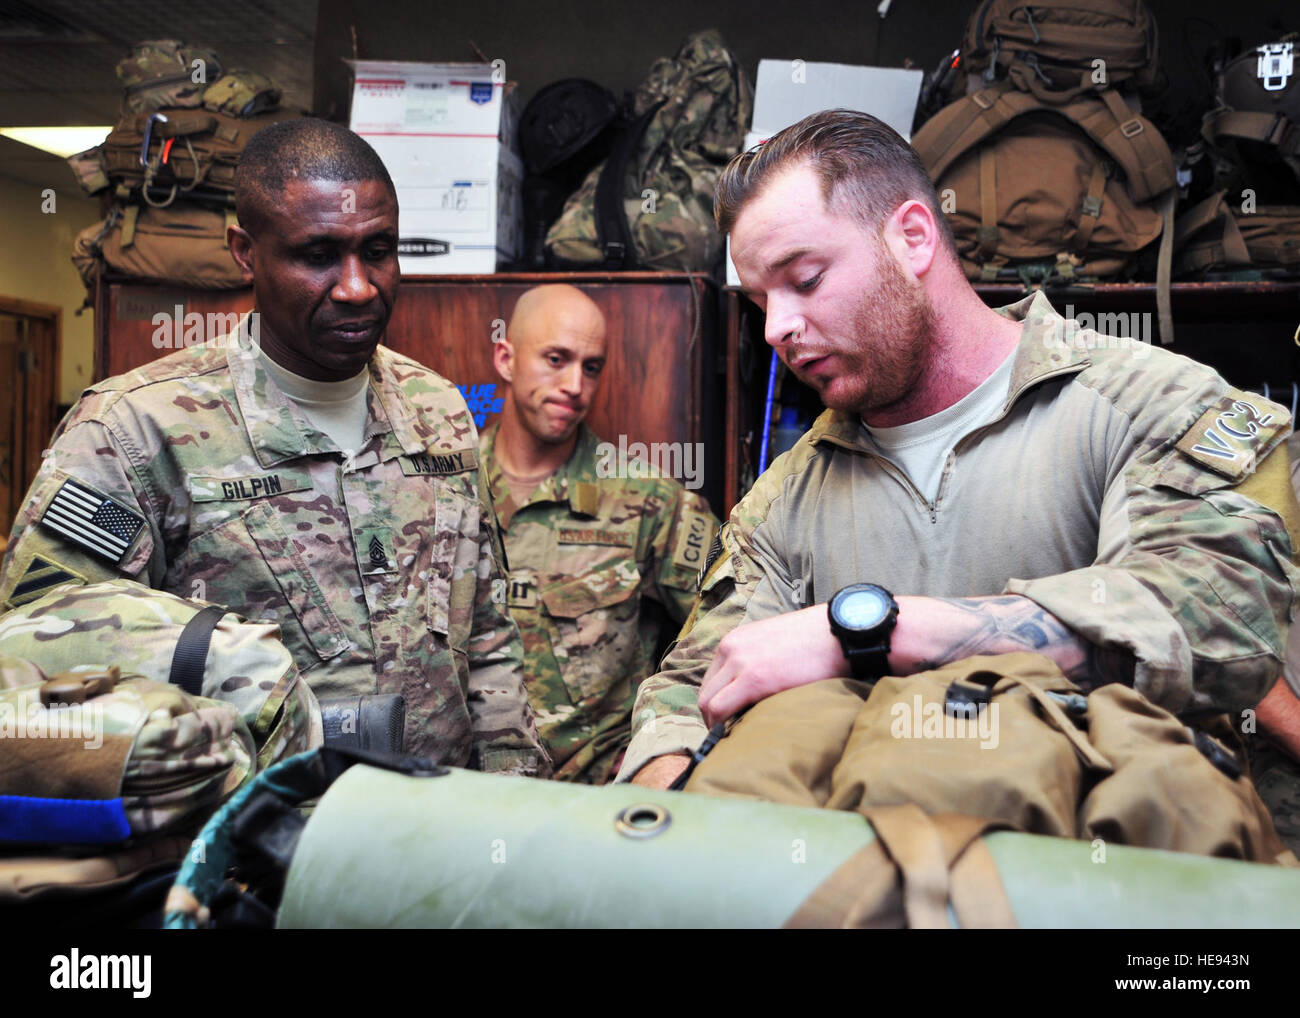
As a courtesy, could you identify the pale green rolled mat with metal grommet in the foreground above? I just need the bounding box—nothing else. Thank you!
[277,764,1300,928]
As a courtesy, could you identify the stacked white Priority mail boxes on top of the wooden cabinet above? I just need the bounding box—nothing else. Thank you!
[348,60,524,276]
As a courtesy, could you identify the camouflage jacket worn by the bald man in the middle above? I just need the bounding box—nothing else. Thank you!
[480,425,718,784]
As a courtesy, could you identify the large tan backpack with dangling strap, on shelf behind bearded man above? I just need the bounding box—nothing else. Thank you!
[913,82,1178,342]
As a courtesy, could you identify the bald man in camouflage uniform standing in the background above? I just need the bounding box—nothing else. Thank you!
[480,285,718,784]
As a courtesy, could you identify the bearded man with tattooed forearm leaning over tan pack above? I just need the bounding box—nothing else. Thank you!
[619,111,1300,785]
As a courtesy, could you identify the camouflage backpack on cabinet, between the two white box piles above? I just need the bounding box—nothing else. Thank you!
[546,30,754,270]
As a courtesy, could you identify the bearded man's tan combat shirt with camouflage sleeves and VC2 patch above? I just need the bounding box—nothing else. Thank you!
[619,294,1300,779]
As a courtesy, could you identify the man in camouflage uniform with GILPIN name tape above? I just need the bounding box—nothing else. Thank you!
[0,120,549,774]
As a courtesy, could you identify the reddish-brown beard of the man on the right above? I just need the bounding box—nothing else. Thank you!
[822,248,936,416]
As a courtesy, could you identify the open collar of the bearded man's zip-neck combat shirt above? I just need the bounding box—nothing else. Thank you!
[809,290,1092,454]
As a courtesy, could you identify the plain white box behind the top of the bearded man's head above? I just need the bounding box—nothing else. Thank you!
[727,60,924,286]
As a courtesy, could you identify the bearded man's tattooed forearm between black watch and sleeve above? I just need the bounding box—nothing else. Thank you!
[919,594,1135,689]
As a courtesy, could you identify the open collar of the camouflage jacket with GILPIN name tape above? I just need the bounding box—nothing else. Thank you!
[226,325,425,467]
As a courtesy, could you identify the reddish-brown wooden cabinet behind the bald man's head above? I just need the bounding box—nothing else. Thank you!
[95,272,731,512]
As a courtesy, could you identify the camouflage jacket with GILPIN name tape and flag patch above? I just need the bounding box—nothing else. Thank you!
[0,337,549,774]
